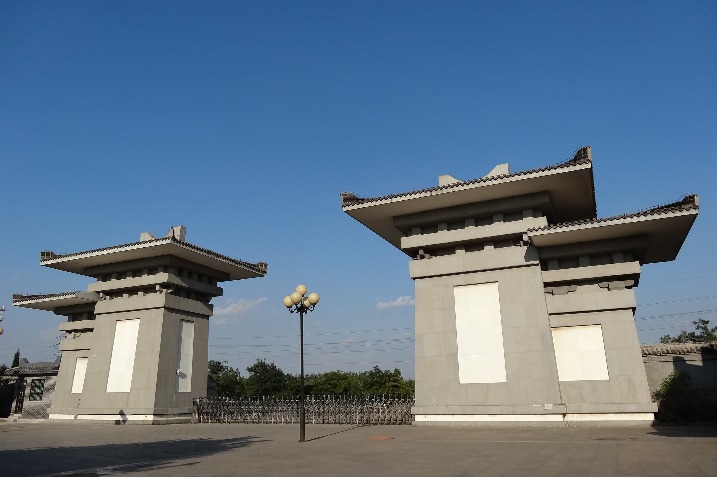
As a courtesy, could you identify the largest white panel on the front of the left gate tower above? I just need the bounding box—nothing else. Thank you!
[107,319,139,392]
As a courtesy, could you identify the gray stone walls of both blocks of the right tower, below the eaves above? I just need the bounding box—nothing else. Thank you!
[409,238,657,424]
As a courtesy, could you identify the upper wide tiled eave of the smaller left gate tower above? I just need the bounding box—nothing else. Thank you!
[40,238,266,280]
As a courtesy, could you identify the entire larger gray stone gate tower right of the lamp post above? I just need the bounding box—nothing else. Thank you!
[342,147,698,425]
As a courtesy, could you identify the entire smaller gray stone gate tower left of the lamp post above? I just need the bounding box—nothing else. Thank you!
[13,226,267,423]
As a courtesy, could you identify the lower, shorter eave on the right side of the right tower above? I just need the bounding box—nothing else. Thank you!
[527,208,698,264]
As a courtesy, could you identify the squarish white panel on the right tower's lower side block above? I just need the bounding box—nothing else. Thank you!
[552,325,610,382]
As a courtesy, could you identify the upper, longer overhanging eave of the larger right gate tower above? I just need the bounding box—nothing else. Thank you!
[342,161,596,249]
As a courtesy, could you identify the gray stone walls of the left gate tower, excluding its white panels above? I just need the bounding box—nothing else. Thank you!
[50,292,211,422]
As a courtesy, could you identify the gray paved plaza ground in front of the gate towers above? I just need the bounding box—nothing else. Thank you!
[0,422,717,476]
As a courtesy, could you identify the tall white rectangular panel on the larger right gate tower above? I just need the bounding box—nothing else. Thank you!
[453,282,507,383]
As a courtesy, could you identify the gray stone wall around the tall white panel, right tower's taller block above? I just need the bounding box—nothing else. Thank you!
[411,247,564,414]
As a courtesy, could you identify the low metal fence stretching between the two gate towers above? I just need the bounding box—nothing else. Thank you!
[194,395,415,425]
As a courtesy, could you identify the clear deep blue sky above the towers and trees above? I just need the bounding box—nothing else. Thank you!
[0,0,717,377]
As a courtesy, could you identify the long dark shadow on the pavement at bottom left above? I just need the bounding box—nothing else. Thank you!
[0,436,267,476]
